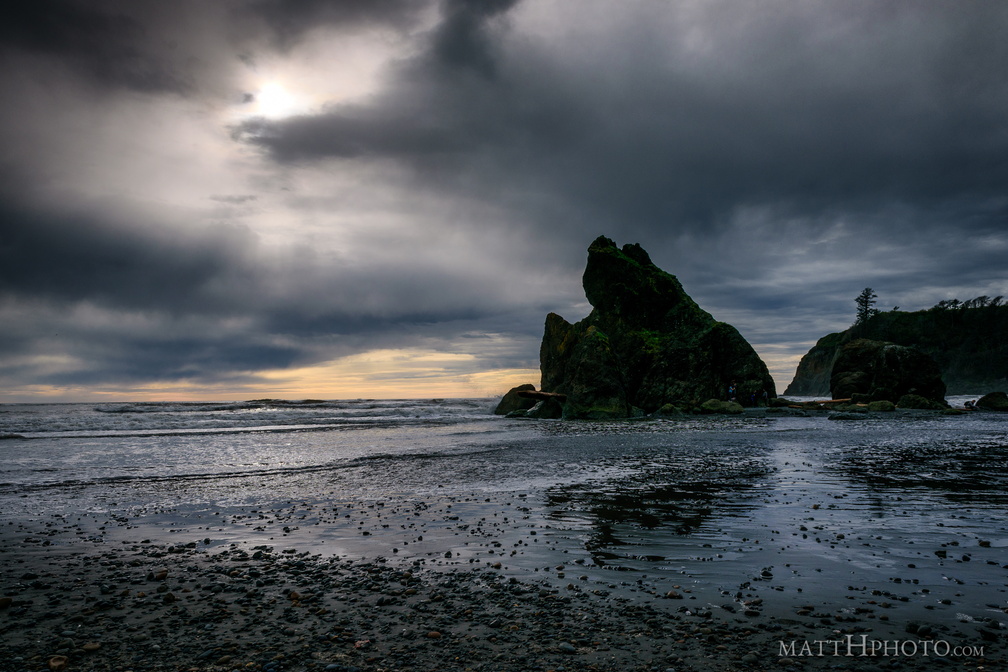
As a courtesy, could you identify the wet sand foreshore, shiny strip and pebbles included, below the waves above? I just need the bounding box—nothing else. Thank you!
[0,493,1008,671]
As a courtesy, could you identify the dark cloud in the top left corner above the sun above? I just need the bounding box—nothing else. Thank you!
[0,0,429,96]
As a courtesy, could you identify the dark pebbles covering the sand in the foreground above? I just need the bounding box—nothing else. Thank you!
[0,499,1004,672]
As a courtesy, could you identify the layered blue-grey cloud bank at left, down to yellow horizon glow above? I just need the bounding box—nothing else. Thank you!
[0,191,544,385]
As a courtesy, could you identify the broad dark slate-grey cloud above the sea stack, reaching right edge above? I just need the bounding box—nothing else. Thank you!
[240,3,1008,240]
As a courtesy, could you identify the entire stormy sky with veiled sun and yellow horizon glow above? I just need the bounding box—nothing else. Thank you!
[0,0,1008,401]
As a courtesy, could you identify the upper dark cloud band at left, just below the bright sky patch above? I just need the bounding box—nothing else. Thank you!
[0,197,544,326]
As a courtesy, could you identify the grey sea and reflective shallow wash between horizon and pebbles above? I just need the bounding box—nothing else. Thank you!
[0,397,1008,627]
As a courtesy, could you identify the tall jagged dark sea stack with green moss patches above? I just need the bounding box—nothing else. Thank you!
[499,237,776,418]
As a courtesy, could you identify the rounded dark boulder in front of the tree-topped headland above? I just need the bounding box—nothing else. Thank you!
[830,339,946,408]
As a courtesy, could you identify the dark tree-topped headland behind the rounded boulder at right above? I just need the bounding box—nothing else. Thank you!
[784,305,1008,396]
